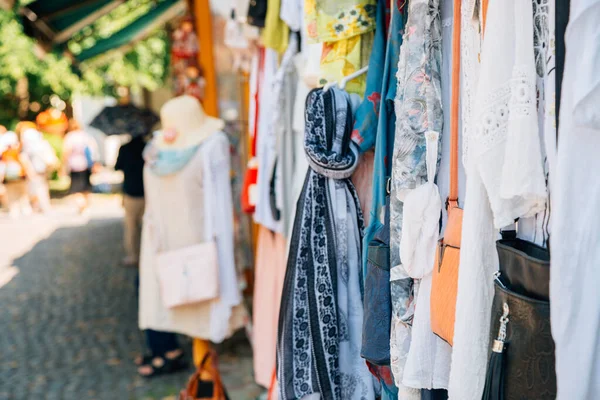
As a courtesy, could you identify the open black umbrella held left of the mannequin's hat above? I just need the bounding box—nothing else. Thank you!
[90,104,159,137]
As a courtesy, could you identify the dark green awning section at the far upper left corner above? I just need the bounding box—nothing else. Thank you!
[21,0,126,47]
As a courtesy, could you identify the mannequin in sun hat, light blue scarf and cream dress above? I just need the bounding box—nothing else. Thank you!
[139,96,247,375]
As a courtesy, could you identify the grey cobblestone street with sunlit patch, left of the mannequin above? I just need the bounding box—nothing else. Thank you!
[0,196,261,400]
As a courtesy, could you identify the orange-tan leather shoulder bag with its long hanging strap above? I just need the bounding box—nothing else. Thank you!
[431,1,463,345]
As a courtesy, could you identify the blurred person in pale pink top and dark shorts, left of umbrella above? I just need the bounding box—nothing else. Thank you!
[62,119,100,213]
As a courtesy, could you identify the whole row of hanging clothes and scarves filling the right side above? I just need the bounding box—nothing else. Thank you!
[212,0,600,400]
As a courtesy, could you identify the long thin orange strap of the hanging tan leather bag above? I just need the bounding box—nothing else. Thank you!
[446,1,461,209]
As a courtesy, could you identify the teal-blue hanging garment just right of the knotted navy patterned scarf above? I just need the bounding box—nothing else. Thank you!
[352,2,404,399]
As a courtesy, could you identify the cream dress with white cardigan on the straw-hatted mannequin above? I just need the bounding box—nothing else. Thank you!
[139,132,247,342]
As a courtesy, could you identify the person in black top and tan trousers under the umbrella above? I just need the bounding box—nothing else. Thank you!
[115,136,146,266]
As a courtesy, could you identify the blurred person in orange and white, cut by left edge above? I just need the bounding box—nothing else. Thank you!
[0,131,33,218]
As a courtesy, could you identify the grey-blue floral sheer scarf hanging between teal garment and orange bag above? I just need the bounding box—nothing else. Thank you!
[390,0,443,398]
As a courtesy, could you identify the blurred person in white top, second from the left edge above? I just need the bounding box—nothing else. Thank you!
[16,121,60,213]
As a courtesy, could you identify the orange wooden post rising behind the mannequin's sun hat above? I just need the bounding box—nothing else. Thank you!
[192,0,219,117]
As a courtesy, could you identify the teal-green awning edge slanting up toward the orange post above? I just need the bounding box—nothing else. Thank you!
[74,0,187,62]
